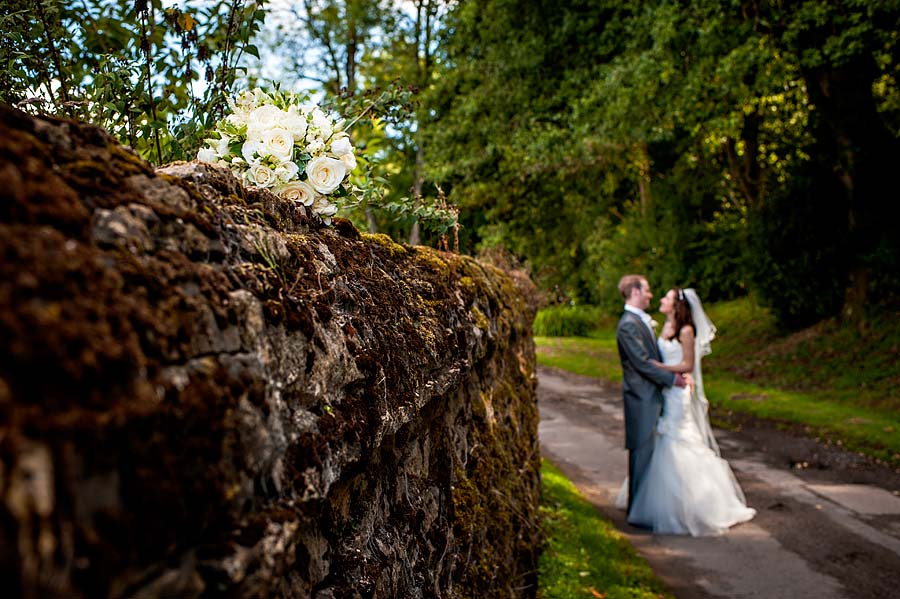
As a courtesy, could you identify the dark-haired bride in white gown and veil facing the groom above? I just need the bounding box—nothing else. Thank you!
[616,287,756,536]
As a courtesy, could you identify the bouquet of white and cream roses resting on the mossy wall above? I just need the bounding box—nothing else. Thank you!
[197,88,356,224]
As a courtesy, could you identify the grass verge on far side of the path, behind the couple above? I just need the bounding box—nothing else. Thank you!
[536,299,900,467]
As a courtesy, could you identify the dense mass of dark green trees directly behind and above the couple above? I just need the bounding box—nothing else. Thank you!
[426,0,900,327]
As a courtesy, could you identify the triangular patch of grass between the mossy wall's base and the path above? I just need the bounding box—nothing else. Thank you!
[538,460,672,599]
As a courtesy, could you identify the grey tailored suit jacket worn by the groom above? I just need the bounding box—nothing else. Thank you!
[616,310,675,449]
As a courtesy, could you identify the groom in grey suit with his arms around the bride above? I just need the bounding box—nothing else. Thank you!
[616,275,685,517]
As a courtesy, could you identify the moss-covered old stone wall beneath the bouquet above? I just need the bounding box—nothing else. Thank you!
[0,106,539,599]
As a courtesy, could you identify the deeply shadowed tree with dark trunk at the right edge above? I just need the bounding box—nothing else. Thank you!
[754,0,900,319]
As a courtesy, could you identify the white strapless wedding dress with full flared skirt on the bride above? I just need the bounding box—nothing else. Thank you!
[616,338,756,536]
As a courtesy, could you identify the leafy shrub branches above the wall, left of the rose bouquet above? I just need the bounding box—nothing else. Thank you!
[0,0,266,164]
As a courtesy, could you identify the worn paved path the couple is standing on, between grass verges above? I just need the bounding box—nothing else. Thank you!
[538,368,900,599]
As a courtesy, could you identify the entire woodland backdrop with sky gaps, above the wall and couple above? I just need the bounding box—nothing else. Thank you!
[7,0,900,329]
